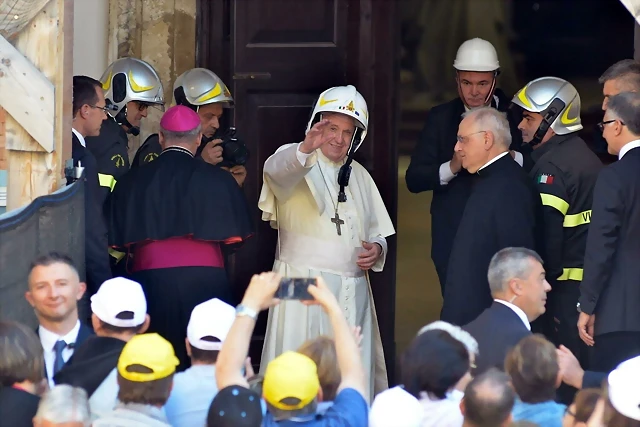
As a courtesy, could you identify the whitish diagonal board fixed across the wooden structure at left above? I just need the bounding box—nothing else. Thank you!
[0,36,55,153]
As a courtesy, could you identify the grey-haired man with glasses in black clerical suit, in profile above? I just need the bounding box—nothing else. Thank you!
[441,107,542,325]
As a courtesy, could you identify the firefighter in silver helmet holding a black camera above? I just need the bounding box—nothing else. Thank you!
[132,68,249,186]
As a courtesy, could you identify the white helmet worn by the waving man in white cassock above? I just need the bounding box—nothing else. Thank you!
[305,85,369,154]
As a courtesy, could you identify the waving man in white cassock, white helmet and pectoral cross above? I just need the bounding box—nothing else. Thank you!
[258,86,395,398]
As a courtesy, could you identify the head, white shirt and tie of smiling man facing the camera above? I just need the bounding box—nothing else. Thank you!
[25,252,91,387]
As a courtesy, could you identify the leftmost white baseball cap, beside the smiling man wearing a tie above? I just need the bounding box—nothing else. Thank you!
[91,277,147,328]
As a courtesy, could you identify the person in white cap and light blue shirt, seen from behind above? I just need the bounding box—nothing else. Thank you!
[164,298,236,427]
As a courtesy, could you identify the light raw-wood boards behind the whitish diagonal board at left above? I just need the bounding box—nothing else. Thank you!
[6,0,73,210]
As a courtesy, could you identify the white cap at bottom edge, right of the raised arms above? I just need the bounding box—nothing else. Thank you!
[369,387,423,427]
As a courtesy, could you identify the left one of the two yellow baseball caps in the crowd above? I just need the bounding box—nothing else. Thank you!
[118,333,180,382]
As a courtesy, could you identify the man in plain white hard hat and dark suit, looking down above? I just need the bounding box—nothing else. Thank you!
[405,38,523,295]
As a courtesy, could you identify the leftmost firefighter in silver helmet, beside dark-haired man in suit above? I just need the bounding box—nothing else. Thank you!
[87,58,164,203]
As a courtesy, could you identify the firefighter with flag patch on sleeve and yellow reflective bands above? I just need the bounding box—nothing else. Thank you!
[513,77,602,374]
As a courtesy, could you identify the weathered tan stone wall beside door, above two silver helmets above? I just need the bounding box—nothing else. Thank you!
[108,0,197,158]
